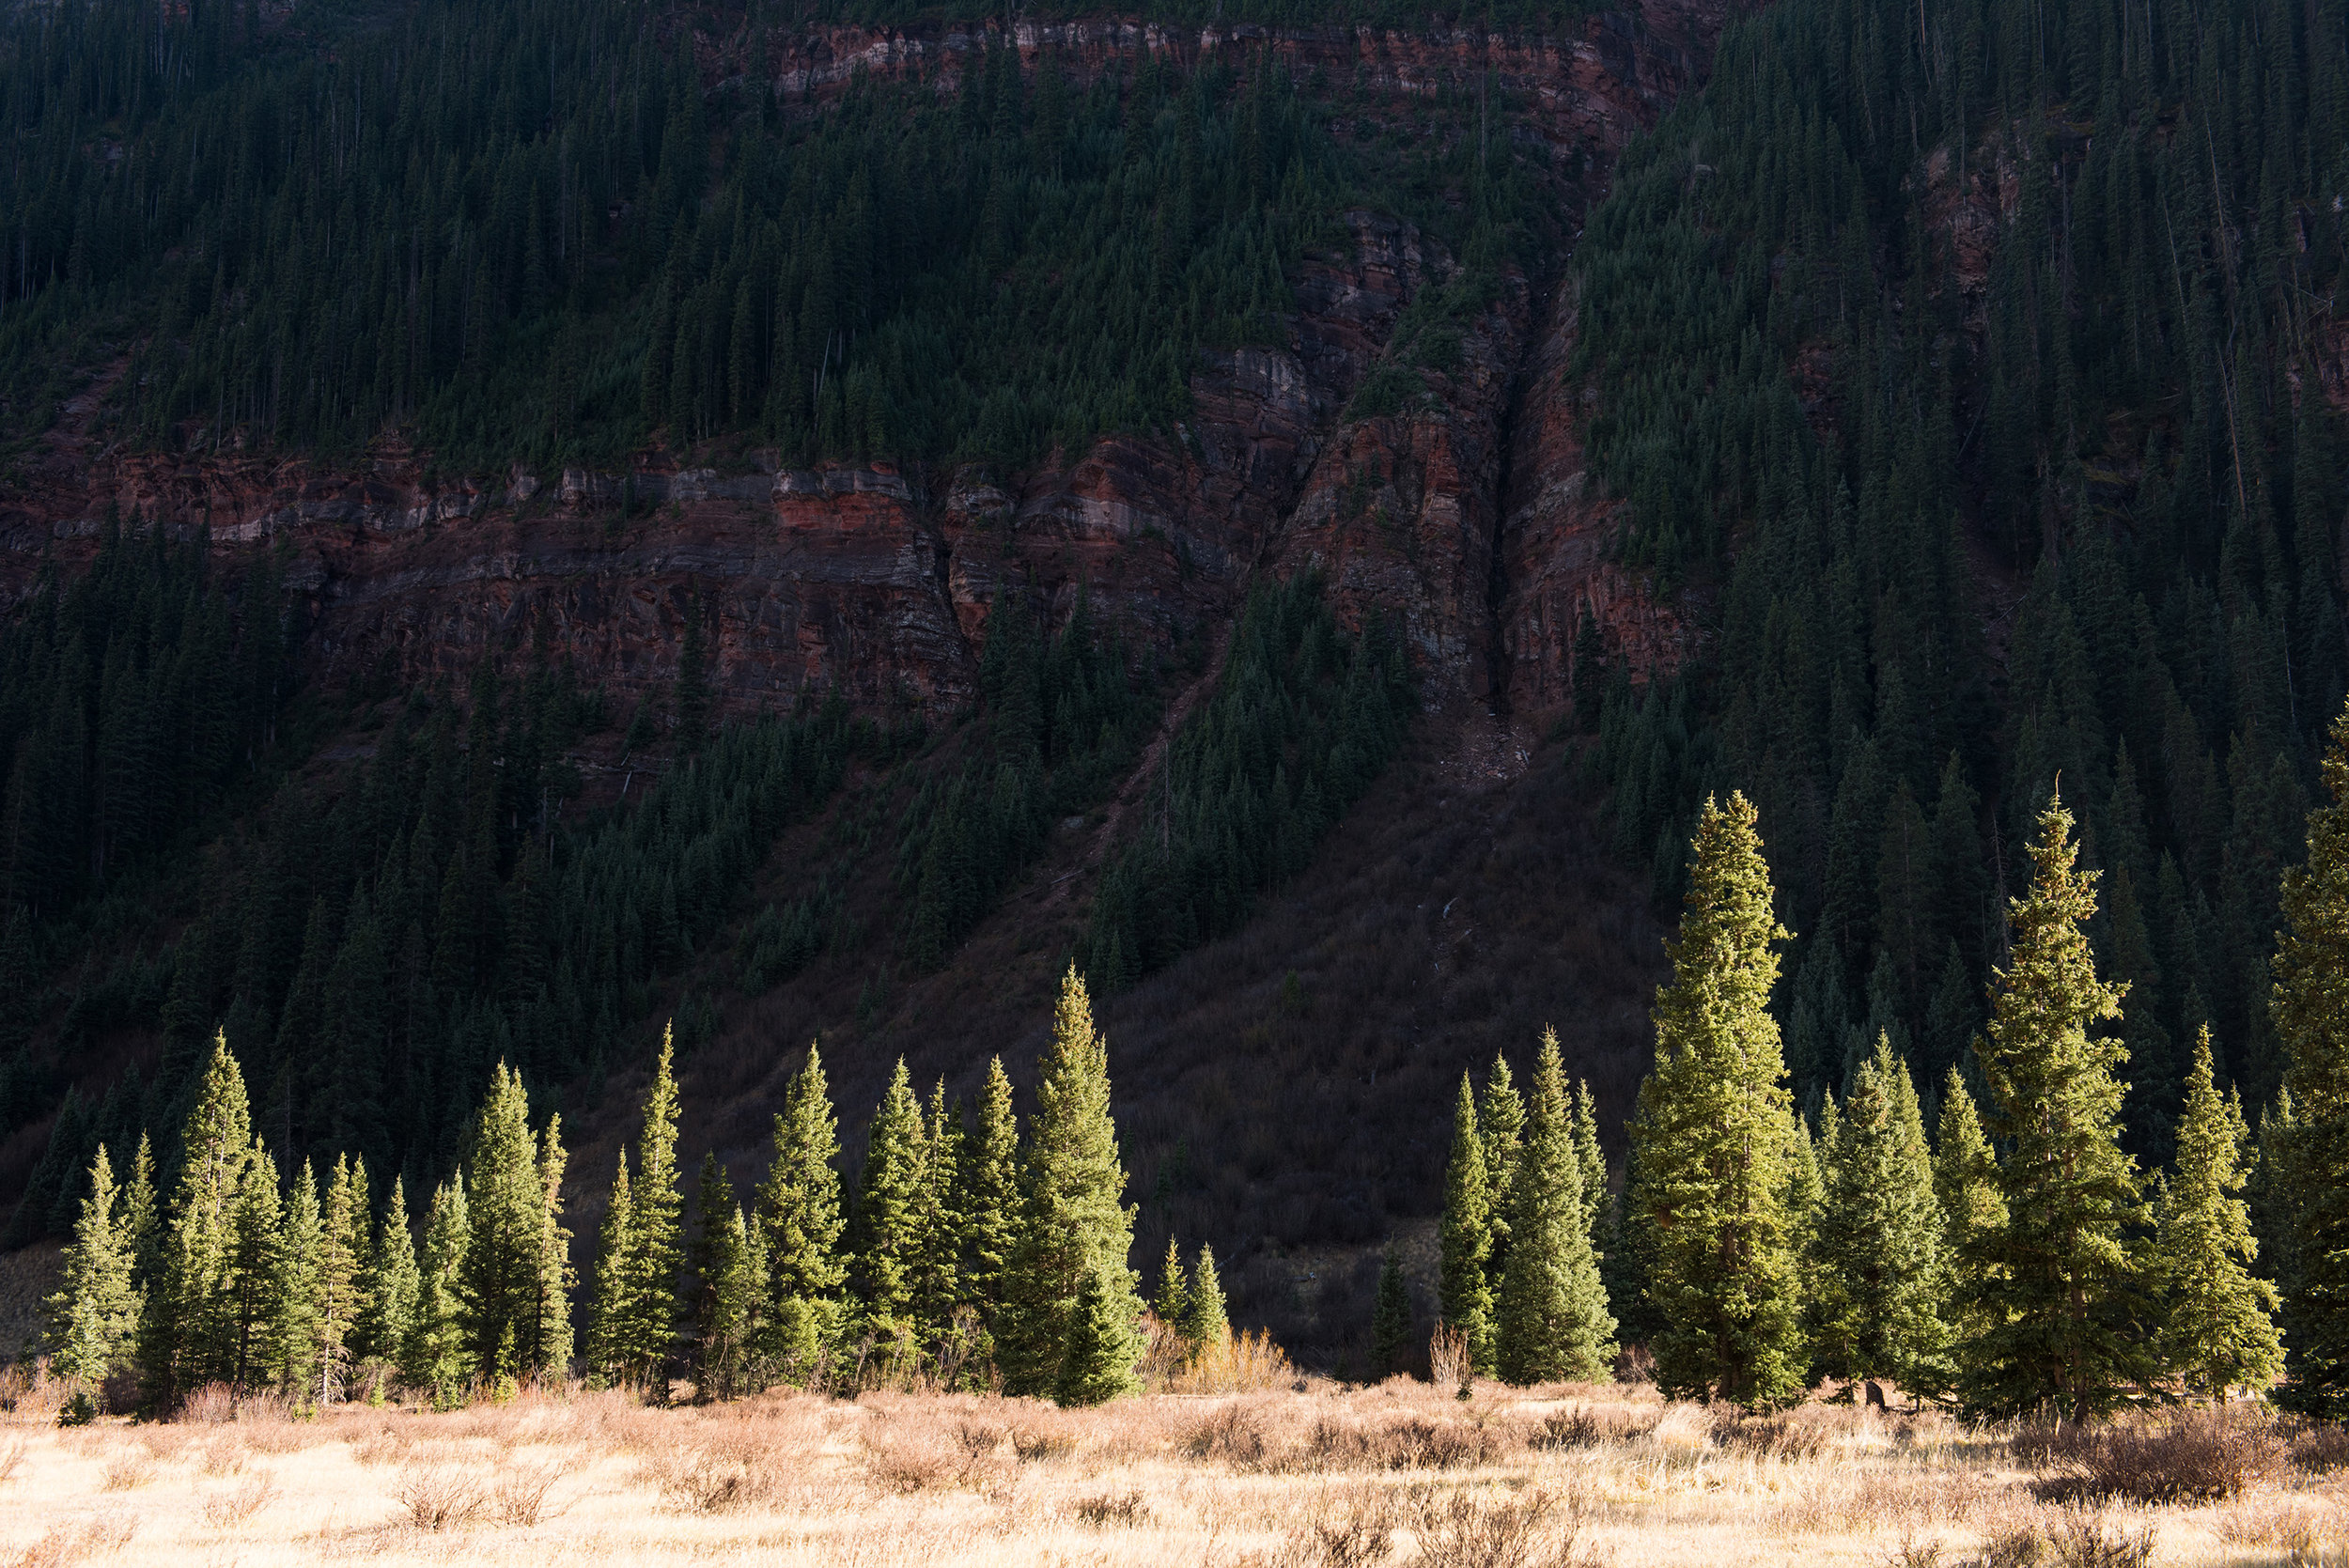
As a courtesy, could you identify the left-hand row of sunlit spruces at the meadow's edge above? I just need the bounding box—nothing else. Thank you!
[50,970,1229,1421]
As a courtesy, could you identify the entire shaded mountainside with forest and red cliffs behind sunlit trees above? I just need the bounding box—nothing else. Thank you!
[0,0,2349,1364]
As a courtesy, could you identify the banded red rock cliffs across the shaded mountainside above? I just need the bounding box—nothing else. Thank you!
[0,0,1724,709]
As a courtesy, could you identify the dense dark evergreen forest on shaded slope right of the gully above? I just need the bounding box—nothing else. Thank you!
[1574,0,2349,1159]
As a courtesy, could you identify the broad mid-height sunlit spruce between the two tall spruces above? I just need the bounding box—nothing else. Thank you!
[1809,1032,1950,1389]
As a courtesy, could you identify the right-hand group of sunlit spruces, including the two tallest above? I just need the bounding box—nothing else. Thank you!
[1442,714,2349,1418]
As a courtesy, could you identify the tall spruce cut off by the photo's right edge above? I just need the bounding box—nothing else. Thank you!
[2269,711,2349,1421]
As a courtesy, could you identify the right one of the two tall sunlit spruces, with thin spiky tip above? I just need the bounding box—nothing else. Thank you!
[1959,798,2156,1421]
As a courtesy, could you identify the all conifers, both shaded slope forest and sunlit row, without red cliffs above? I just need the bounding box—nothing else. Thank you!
[0,0,2349,1446]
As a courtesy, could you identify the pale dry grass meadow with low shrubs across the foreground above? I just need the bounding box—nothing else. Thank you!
[0,1380,2349,1568]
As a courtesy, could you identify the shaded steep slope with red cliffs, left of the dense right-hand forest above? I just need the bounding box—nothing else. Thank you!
[0,5,1722,1357]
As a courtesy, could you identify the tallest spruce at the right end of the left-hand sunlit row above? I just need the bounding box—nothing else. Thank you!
[996,965,1142,1404]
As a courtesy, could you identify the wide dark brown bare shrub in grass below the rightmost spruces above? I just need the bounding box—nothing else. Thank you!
[2015,1411,2286,1502]
